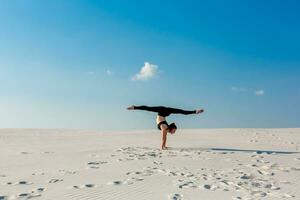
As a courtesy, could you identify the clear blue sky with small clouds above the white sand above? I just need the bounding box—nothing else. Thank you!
[0,0,300,130]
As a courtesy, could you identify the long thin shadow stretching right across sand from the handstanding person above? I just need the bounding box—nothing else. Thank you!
[170,147,300,154]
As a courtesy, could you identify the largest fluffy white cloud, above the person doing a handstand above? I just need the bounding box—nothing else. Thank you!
[132,62,159,81]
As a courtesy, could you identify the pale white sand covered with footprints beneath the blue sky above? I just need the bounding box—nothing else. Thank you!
[0,129,300,200]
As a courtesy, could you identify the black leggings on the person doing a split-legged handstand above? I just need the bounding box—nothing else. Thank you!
[134,106,196,117]
